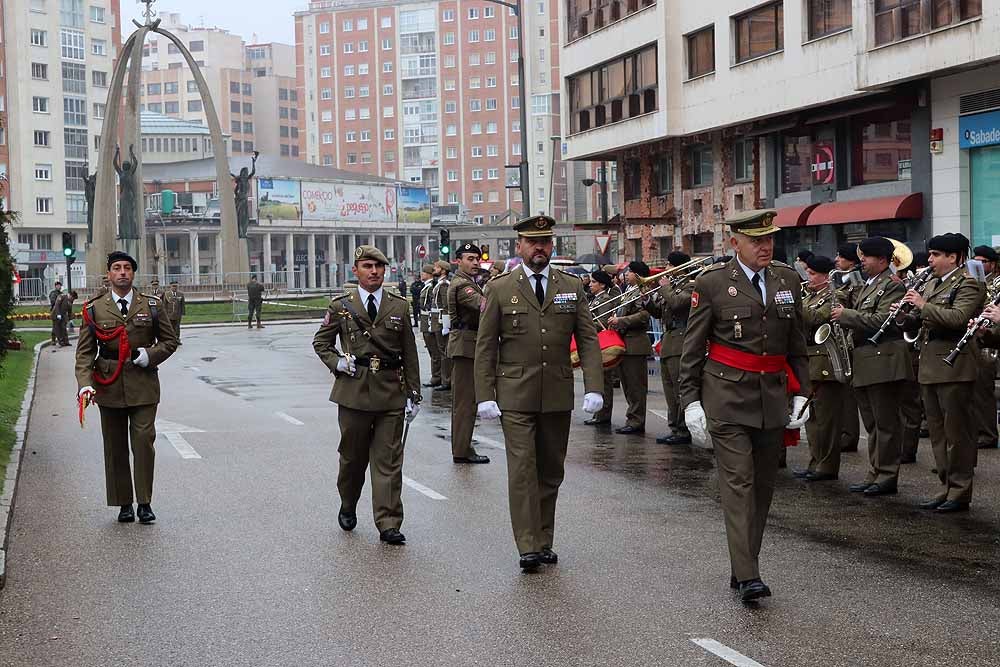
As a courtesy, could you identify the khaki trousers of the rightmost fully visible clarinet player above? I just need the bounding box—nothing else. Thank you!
[920,382,976,503]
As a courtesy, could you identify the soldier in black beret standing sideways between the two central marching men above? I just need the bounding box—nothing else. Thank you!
[448,243,490,463]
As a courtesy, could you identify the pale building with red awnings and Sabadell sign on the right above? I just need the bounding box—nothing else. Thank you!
[560,0,1000,258]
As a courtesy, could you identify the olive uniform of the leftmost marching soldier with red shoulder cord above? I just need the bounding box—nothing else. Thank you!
[76,290,177,507]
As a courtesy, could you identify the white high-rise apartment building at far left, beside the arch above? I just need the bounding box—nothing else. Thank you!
[0,0,121,282]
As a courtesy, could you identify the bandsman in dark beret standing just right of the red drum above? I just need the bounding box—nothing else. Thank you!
[608,261,653,435]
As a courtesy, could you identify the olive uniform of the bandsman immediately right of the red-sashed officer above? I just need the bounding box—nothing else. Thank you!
[802,288,844,476]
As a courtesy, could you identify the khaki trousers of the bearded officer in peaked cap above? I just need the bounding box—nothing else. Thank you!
[500,410,572,554]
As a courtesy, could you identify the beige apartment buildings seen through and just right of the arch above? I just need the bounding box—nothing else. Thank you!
[141,12,298,156]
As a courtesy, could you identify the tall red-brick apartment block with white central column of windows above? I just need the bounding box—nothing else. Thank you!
[295,0,586,228]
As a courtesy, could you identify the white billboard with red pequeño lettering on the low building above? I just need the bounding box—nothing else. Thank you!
[302,181,396,224]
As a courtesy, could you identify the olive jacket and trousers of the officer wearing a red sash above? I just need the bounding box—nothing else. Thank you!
[680,258,810,581]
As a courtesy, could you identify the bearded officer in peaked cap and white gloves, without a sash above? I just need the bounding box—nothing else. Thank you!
[475,215,603,571]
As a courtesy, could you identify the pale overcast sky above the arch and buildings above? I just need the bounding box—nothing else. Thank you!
[121,0,309,44]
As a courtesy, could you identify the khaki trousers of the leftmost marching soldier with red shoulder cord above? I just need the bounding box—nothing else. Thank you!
[98,403,157,507]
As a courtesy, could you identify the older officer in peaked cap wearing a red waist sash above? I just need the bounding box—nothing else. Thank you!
[680,209,810,602]
